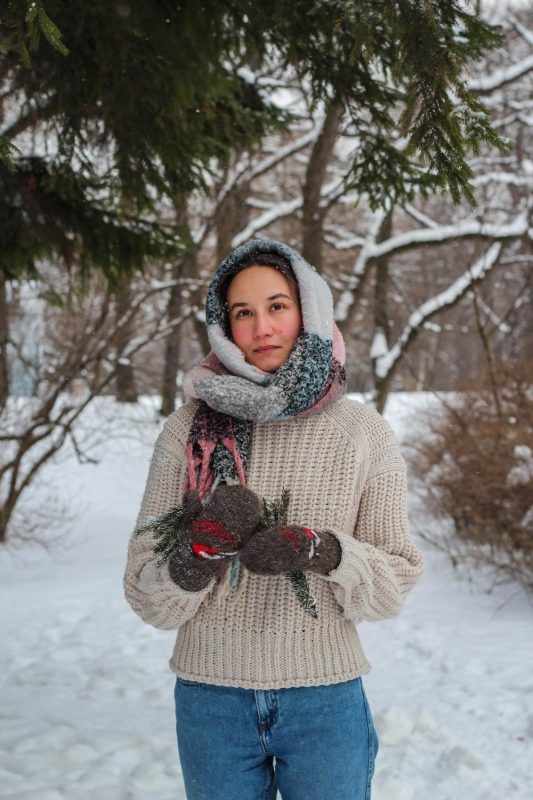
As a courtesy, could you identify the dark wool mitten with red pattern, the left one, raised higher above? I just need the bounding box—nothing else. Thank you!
[168,485,261,592]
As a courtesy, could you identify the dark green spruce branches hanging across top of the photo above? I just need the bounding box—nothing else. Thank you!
[0,0,504,278]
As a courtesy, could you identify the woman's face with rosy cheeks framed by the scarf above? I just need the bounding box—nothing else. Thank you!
[226,266,302,372]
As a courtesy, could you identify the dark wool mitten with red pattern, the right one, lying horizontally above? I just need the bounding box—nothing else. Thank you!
[239,525,342,575]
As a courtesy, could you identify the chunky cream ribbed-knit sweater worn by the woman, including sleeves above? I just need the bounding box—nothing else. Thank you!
[124,397,423,689]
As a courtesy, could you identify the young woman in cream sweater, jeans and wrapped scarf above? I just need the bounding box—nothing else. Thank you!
[125,240,423,800]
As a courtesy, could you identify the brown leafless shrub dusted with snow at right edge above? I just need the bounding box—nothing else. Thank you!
[411,365,533,591]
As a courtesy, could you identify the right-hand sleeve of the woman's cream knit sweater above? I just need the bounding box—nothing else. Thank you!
[324,414,424,622]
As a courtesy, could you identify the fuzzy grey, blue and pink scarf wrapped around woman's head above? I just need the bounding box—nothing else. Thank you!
[184,239,346,499]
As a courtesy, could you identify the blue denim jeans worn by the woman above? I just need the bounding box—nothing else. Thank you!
[174,678,378,800]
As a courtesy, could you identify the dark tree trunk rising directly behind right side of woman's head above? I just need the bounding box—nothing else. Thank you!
[302,100,344,272]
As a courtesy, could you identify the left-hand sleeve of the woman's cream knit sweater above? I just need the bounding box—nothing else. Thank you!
[124,412,215,629]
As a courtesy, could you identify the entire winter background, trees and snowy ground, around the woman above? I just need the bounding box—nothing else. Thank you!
[0,0,533,800]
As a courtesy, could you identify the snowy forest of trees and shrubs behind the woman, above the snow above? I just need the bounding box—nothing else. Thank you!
[0,0,533,585]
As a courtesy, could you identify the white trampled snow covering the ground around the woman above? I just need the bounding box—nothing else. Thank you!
[0,395,533,800]
